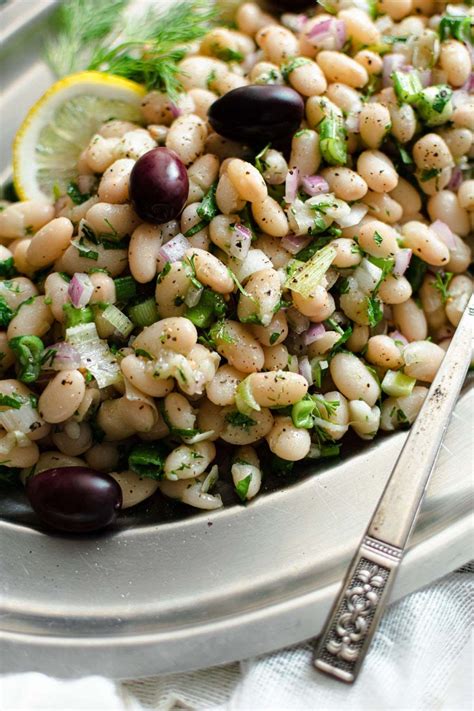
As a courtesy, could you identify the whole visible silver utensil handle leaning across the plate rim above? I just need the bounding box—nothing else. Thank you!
[314,296,474,683]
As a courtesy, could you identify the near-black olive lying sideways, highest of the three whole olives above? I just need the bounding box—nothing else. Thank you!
[208,85,304,145]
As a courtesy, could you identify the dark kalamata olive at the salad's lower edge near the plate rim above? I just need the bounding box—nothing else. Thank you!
[26,467,122,533]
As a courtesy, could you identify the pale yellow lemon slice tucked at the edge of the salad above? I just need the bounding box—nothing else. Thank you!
[13,72,146,200]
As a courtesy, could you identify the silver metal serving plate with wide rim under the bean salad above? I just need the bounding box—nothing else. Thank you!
[0,0,473,678]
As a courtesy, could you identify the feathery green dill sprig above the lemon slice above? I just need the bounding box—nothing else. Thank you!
[47,0,217,98]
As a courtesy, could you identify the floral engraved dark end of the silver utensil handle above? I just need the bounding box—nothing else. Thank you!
[314,536,401,682]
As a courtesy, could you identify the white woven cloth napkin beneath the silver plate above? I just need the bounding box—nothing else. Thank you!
[0,564,474,711]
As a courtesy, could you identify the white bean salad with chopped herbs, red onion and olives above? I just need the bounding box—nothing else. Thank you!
[0,0,474,531]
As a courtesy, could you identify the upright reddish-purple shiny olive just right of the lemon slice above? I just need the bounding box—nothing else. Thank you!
[129,148,189,225]
